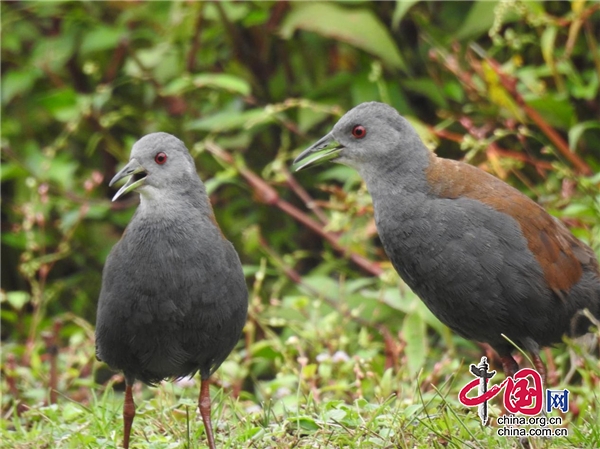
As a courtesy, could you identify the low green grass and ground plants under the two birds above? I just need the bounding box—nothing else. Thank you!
[0,290,600,449]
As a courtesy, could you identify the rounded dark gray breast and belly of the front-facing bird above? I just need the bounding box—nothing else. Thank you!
[96,212,247,382]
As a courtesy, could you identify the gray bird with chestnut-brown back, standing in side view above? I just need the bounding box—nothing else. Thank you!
[294,102,600,377]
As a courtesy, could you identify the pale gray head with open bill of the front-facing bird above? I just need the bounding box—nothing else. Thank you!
[109,132,198,201]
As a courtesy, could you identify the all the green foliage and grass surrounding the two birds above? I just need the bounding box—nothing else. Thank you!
[0,0,600,448]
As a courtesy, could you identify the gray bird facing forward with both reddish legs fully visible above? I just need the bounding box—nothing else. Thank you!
[96,133,248,449]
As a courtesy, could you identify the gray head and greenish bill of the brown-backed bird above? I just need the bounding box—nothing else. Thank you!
[294,102,423,174]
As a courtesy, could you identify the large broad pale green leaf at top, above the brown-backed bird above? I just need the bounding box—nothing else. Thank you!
[280,2,406,69]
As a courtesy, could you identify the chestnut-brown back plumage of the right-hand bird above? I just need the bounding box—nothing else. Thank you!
[427,156,598,297]
